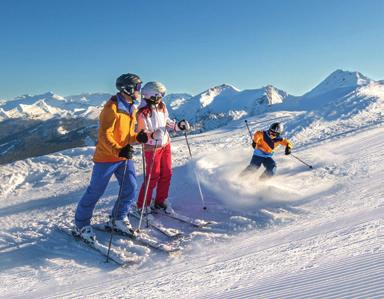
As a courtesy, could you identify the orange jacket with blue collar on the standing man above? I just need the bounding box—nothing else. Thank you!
[93,93,137,162]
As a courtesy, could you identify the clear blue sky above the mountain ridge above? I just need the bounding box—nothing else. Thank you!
[0,0,384,99]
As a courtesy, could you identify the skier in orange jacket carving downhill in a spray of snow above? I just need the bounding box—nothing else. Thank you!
[241,123,292,179]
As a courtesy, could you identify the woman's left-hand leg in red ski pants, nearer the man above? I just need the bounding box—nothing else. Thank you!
[137,149,161,209]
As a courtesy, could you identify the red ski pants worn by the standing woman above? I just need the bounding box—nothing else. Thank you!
[137,143,172,209]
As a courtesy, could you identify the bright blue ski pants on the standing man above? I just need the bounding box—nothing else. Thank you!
[75,160,137,229]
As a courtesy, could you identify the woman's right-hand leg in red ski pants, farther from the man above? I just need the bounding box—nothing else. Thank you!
[155,143,172,204]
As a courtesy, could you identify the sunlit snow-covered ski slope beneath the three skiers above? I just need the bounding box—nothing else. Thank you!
[0,109,384,298]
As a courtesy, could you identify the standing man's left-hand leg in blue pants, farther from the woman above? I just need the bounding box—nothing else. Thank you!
[75,163,118,229]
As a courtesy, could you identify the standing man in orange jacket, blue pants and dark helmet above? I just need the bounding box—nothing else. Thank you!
[75,74,148,243]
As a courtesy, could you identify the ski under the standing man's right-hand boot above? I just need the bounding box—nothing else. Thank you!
[92,223,182,253]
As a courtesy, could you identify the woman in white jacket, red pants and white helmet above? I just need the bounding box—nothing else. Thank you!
[137,82,190,213]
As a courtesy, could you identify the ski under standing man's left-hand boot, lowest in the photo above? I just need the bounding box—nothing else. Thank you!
[58,226,142,266]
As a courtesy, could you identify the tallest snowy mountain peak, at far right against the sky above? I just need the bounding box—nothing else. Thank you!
[305,69,373,97]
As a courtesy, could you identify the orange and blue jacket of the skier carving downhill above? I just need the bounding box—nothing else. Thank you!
[253,131,292,158]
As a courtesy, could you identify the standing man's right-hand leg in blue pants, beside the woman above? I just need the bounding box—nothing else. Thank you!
[112,160,137,220]
